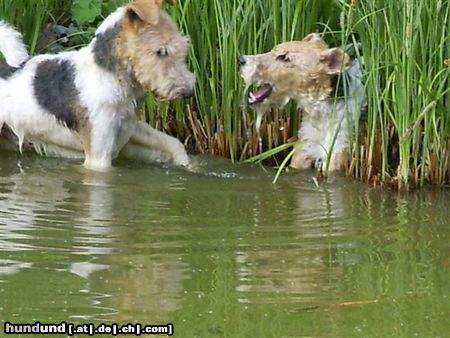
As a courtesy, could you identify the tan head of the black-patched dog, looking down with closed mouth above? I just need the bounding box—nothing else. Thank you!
[117,0,195,100]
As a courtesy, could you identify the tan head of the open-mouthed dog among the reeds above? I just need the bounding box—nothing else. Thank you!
[239,34,351,128]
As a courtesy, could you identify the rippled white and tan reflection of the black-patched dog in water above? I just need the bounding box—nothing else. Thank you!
[0,154,185,320]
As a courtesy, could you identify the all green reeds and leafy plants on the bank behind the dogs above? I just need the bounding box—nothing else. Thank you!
[0,0,450,188]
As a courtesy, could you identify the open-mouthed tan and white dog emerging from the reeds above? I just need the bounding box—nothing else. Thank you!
[239,34,365,170]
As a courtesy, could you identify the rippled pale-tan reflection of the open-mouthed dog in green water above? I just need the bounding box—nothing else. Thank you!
[235,180,359,303]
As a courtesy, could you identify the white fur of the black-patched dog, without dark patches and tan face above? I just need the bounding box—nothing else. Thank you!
[0,8,189,170]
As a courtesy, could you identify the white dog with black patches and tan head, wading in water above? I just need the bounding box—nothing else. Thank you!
[0,0,195,170]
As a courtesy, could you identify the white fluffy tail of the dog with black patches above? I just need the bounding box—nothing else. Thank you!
[0,20,29,68]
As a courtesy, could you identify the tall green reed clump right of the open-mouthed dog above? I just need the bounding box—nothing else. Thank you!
[340,0,450,188]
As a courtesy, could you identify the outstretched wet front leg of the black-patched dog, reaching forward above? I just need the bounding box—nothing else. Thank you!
[122,121,189,166]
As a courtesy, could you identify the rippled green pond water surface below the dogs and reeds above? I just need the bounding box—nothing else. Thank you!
[0,152,450,337]
